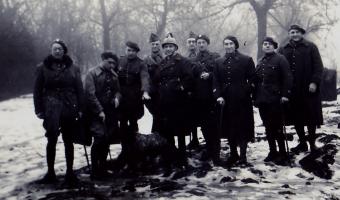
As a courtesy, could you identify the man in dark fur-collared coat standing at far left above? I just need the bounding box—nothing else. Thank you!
[33,39,83,184]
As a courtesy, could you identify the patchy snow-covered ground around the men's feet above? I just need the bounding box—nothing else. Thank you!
[0,95,340,199]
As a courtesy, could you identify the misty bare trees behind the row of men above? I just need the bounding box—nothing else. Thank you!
[0,0,337,100]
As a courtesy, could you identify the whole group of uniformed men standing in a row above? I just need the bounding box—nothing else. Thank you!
[34,25,323,182]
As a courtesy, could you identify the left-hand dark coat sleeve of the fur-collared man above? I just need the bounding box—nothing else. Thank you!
[33,65,44,114]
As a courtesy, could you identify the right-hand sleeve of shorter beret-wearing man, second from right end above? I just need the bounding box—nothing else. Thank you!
[280,56,293,97]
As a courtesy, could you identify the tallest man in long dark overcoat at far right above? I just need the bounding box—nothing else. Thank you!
[279,25,323,153]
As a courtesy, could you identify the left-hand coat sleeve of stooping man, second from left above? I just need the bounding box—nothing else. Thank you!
[85,71,103,114]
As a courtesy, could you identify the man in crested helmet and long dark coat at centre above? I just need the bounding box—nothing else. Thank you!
[158,33,193,166]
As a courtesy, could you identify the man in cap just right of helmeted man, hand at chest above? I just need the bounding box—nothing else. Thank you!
[193,35,220,164]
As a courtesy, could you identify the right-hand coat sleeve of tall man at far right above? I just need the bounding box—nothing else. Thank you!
[311,45,323,86]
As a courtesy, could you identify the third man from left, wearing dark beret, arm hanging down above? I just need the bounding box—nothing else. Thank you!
[118,41,150,137]
